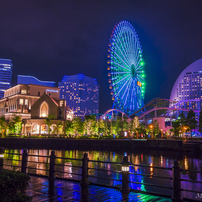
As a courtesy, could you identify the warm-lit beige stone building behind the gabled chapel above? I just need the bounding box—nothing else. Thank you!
[0,84,59,120]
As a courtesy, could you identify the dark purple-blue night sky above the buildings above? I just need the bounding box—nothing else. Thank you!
[0,0,202,113]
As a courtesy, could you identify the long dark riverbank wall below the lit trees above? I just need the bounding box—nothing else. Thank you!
[0,138,202,153]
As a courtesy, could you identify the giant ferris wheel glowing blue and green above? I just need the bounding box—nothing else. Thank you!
[107,21,145,115]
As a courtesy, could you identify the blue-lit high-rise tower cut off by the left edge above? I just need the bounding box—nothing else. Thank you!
[0,59,12,99]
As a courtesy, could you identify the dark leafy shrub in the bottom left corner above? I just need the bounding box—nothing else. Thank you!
[0,170,31,202]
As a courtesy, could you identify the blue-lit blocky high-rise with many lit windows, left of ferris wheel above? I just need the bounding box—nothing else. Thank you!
[59,74,99,119]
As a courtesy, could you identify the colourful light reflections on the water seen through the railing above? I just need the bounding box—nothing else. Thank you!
[4,149,202,198]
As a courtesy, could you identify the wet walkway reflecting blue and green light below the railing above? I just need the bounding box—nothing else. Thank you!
[26,176,171,202]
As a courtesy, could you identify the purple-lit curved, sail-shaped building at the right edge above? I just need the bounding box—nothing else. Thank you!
[170,58,202,118]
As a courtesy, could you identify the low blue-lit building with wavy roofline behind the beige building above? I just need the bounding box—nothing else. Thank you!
[17,75,55,87]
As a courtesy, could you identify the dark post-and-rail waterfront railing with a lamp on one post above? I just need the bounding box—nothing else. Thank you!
[0,148,202,202]
